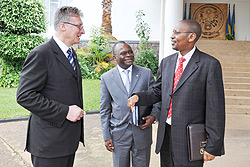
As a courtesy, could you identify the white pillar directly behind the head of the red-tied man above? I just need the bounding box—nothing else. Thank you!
[159,0,184,61]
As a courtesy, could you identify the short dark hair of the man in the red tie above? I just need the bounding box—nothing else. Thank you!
[180,20,202,42]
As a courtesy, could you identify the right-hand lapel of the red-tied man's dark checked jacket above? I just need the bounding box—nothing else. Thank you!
[175,49,200,92]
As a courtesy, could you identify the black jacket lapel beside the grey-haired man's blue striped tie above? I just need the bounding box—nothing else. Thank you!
[49,39,77,78]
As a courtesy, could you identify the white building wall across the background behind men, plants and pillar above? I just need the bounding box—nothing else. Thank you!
[46,0,250,41]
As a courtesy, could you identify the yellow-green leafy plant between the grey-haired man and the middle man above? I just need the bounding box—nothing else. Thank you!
[77,26,115,79]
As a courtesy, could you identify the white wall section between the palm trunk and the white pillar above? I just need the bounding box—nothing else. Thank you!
[111,0,161,41]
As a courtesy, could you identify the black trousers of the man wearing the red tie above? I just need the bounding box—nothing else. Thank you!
[160,123,203,167]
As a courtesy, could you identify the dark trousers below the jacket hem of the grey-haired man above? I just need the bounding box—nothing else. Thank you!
[31,154,75,167]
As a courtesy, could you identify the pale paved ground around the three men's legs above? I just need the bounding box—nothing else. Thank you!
[0,114,250,167]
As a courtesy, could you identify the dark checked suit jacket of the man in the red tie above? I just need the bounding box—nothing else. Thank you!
[137,49,225,166]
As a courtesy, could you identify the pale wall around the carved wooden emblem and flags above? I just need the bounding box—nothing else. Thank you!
[184,0,250,41]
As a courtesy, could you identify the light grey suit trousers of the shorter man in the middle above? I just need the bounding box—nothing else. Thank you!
[113,124,151,167]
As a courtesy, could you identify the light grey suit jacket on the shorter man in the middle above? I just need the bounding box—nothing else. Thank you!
[100,65,159,149]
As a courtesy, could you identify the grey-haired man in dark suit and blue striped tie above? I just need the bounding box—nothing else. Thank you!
[17,6,85,167]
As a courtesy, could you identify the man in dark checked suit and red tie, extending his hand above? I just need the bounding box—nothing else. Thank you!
[128,20,225,167]
